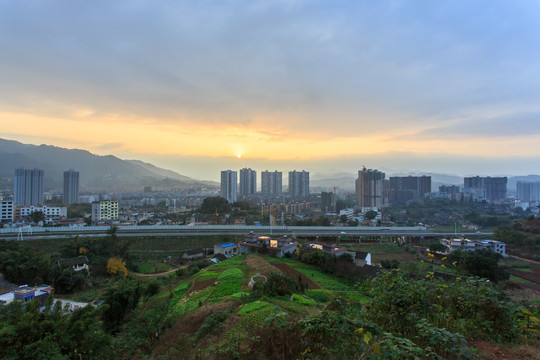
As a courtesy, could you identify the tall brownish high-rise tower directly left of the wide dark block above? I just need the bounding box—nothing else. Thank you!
[356,168,385,208]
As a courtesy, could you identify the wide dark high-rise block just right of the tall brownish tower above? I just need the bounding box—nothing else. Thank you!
[388,176,431,203]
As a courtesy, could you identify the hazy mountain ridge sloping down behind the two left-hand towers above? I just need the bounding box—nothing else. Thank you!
[0,139,217,191]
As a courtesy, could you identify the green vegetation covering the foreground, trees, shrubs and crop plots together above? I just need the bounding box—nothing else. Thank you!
[0,230,540,359]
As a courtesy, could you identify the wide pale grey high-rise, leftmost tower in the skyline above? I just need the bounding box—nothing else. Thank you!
[14,168,44,205]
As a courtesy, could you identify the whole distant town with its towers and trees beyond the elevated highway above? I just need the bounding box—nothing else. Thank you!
[0,167,540,230]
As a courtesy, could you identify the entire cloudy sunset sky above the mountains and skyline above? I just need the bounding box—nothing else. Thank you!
[0,0,540,180]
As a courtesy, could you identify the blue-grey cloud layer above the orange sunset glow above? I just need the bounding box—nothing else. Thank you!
[0,0,540,136]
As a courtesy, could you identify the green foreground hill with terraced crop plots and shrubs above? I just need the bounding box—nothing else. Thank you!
[132,255,536,359]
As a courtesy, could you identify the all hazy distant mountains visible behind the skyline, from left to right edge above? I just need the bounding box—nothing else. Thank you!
[0,139,540,192]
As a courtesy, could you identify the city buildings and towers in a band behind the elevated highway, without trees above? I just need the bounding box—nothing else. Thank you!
[0,160,540,228]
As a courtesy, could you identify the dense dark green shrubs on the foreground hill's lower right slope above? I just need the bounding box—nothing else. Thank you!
[239,270,538,359]
